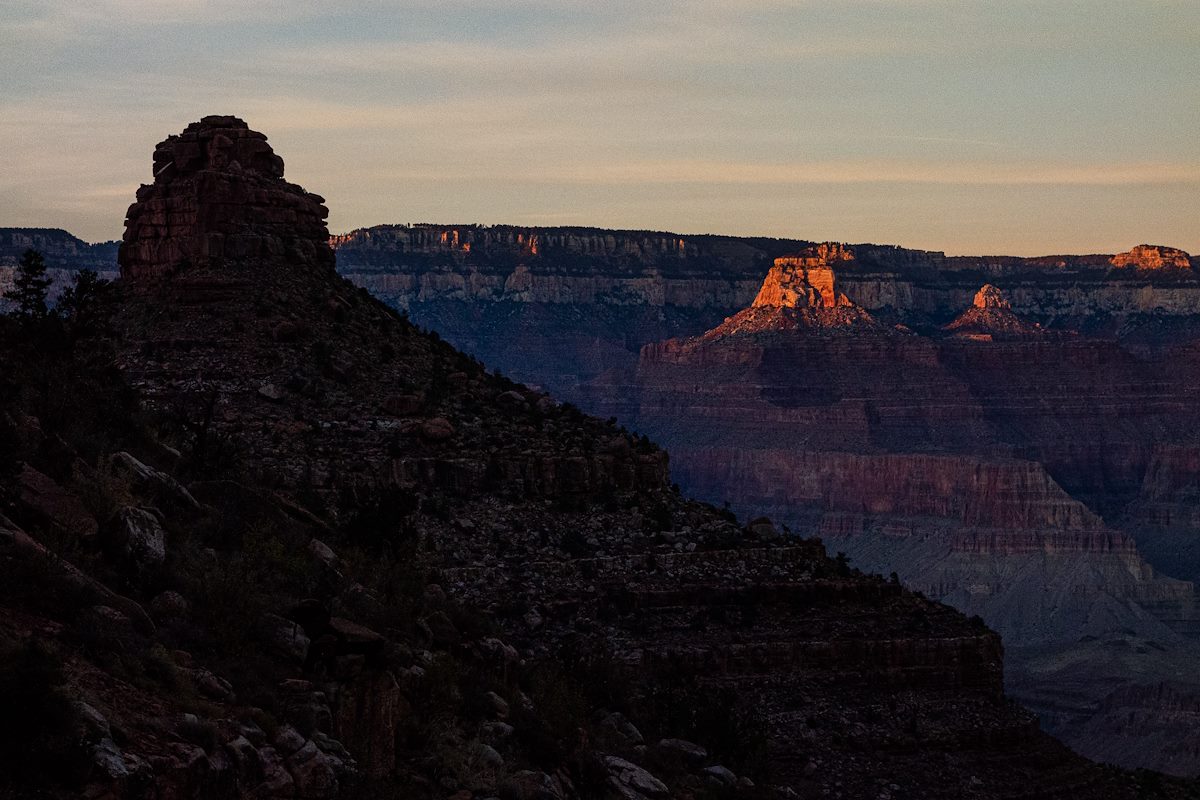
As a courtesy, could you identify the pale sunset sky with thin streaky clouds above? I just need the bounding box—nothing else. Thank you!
[0,0,1200,255]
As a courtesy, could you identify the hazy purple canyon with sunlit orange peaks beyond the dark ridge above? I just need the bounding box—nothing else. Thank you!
[337,225,1200,774]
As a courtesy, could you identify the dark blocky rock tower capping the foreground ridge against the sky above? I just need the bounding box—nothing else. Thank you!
[119,116,334,285]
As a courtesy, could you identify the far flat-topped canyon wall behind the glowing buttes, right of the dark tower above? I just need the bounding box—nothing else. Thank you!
[334,224,1200,396]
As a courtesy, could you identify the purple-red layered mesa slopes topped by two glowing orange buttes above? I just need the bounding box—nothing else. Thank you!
[566,251,1198,772]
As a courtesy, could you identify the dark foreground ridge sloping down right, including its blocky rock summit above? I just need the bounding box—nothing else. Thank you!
[0,116,1187,800]
